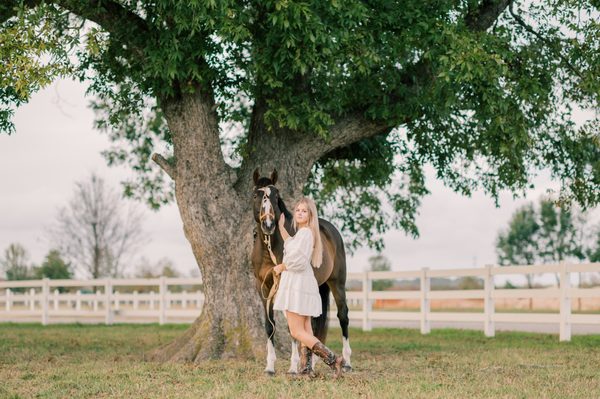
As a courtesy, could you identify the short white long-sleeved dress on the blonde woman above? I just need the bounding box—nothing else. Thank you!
[273,227,322,317]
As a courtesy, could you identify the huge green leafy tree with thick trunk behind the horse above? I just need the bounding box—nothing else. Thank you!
[0,0,600,361]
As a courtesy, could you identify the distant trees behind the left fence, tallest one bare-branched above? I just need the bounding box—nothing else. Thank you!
[0,174,186,280]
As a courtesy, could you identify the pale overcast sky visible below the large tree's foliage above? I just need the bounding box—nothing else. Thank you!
[0,80,596,282]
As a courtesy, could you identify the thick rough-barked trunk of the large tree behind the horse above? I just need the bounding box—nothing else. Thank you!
[152,90,314,362]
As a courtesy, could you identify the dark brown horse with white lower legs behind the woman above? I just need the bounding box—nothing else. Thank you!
[252,169,352,375]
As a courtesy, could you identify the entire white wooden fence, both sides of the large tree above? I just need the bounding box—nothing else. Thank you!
[0,263,600,341]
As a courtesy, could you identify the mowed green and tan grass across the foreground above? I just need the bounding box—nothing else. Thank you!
[0,324,600,399]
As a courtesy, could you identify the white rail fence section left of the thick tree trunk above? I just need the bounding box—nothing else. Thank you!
[0,277,204,325]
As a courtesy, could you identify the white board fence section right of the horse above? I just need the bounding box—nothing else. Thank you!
[347,263,600,341]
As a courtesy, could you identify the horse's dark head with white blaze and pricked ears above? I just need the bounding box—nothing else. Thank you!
[253,168,281,235]
